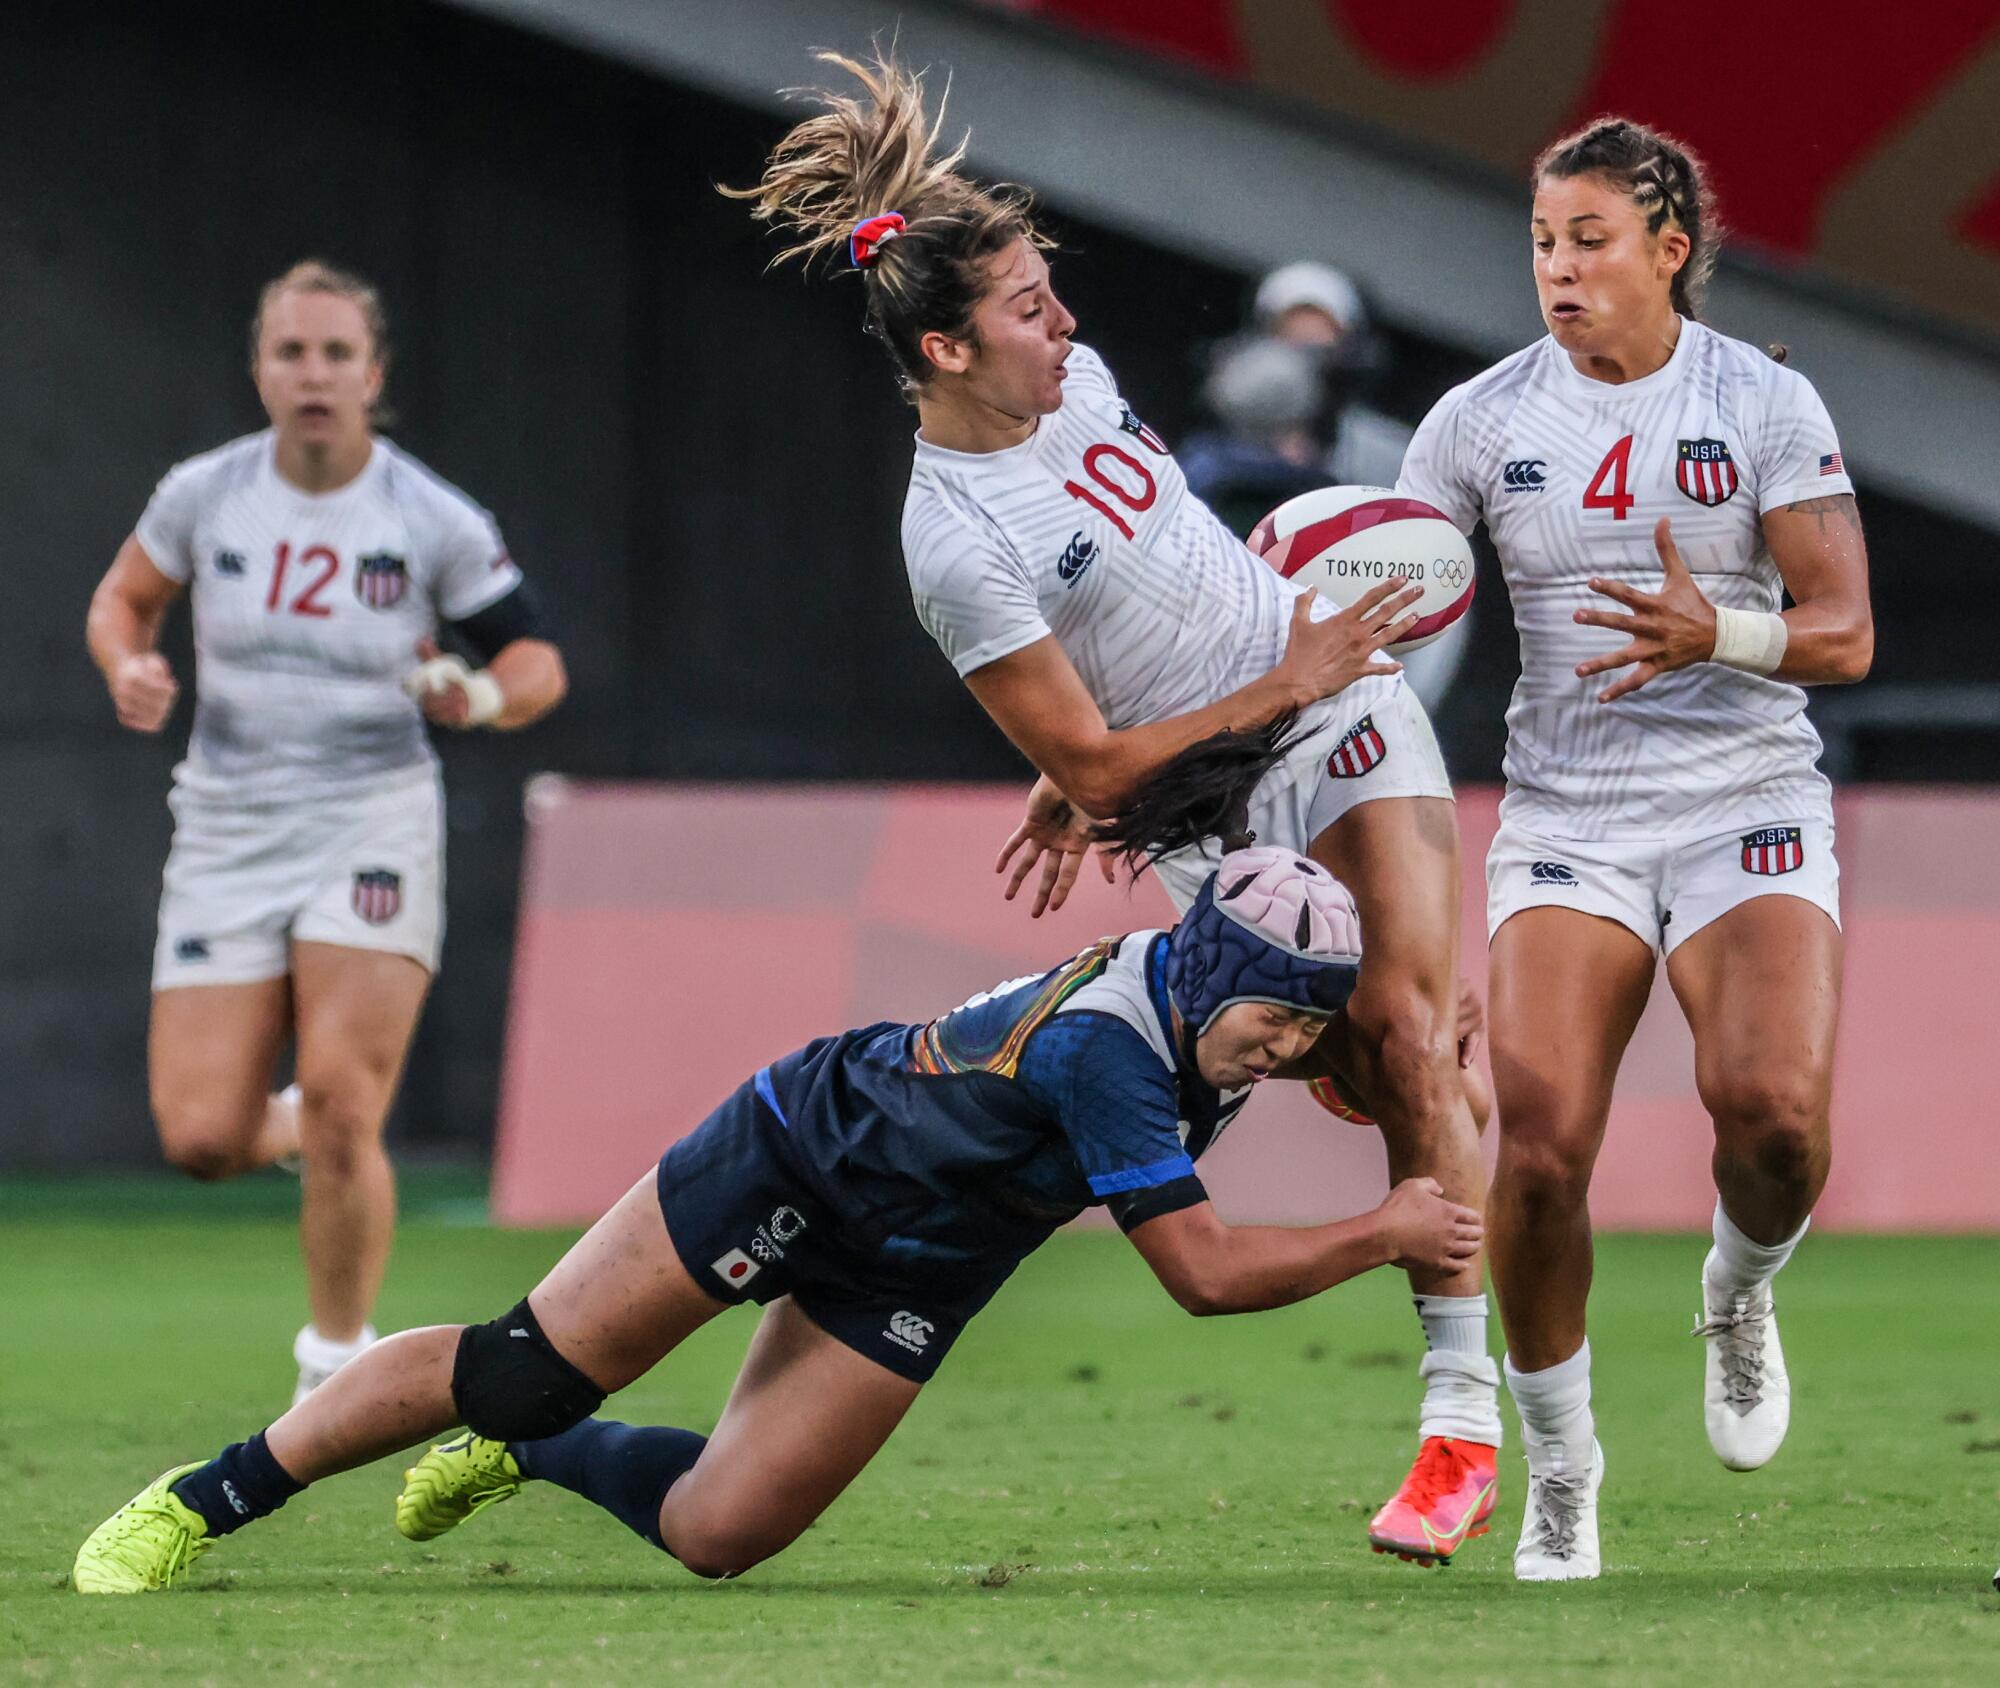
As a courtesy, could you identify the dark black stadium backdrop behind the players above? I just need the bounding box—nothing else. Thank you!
[0,0,2000,1170]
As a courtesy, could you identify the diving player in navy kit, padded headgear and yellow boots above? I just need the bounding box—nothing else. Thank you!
[74,846,1482,1594]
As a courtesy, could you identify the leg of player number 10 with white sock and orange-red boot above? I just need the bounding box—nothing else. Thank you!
[1312,798,1500,1564]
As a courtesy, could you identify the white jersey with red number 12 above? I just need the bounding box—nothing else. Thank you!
[136,428,520,802]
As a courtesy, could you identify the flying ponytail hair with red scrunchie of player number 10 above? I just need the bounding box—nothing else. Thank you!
[718,52,1052,400]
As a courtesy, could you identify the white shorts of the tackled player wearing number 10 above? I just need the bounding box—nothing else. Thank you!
[1154,676,1452,910]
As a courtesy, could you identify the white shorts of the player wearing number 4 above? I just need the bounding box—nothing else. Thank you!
[1486,816,1840,956]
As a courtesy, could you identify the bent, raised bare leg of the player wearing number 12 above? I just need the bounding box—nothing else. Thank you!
[146,976,298,1182]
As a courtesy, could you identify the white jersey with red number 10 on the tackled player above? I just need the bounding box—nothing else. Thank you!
[902,346,1400,730]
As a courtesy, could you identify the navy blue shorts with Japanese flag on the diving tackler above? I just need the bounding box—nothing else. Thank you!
[654,1062,1020,1384]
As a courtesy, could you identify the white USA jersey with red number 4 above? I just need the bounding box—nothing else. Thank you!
[1398,322,1854,838]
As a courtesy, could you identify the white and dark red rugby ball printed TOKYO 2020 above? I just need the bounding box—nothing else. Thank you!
[1250,486,1478,656]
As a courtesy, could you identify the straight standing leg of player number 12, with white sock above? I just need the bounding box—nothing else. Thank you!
[292,942,430,1392]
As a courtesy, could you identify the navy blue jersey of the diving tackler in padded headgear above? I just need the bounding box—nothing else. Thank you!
[754,932,1250,1264]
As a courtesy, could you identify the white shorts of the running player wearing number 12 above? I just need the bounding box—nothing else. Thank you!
[152,766,444,990]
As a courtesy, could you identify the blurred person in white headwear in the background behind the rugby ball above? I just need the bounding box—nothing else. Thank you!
[1178,262,1472,710]
